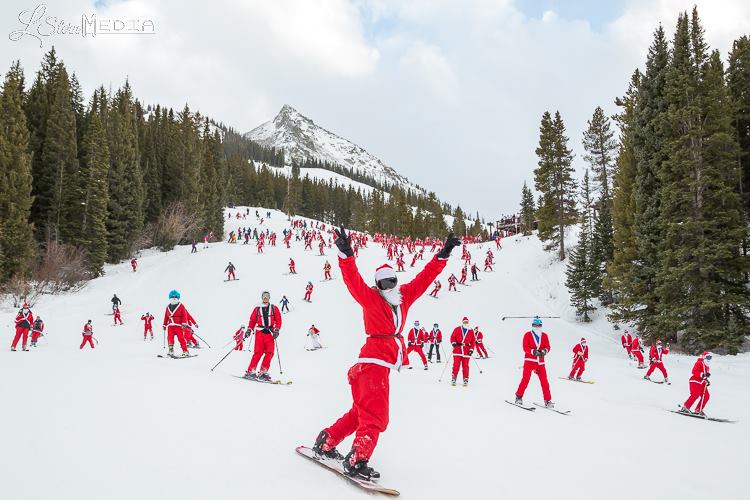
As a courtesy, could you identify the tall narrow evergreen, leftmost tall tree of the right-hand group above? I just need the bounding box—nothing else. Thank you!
[534,111,576,260]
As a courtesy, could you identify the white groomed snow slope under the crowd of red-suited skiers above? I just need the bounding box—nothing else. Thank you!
[0,208,750,500]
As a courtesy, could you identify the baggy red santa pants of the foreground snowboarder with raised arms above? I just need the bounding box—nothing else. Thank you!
[326,363,390,462]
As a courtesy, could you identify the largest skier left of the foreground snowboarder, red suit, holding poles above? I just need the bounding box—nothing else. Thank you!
[245,291,281,382]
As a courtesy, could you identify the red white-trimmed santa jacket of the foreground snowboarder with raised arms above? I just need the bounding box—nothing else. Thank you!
[339,256,448,370]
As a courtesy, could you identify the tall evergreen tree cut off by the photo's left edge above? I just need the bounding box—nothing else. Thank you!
[0,61,34,283]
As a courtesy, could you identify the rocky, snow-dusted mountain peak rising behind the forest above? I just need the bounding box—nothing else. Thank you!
[245,104,421,191]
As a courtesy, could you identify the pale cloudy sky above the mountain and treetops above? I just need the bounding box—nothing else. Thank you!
[0,0,750,219]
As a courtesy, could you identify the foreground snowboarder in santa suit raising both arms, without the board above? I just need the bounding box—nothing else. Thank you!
[313,227,461,480]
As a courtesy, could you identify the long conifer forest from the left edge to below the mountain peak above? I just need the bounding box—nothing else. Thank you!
[0,48,482,285]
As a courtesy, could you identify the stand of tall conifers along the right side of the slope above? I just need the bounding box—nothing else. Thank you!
[522,8,750,353]
